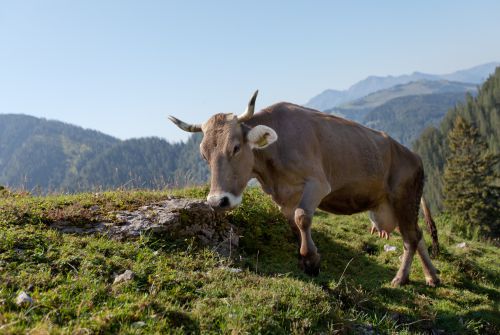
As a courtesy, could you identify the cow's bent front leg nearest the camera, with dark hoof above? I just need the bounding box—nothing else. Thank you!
[295,179,331,276]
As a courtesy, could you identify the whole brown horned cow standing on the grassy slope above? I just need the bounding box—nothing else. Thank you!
[170,92,439,286]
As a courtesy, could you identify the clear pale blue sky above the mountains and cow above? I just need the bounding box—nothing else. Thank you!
[0,0,500,141]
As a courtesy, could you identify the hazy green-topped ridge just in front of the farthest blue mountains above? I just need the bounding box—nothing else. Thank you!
[325,80,477,122]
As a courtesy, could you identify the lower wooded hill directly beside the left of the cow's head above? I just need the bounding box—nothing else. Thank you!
[69,135,208,190]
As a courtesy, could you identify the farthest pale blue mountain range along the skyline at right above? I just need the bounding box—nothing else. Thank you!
[305,62,500,111]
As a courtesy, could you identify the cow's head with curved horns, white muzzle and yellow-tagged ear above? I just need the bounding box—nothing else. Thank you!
[169,91,278,210]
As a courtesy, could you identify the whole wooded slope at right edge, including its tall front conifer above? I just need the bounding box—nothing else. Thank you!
[414,68,500,238]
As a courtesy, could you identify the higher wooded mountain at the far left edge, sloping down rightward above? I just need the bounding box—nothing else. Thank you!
[0,114,119,190]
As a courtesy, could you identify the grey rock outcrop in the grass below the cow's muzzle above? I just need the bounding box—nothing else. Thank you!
[50,198,238,254]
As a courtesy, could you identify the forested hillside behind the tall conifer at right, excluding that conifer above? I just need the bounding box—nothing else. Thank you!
[415,68,500,213]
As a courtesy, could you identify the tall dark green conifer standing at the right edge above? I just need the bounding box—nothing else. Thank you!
[444,116,500,237]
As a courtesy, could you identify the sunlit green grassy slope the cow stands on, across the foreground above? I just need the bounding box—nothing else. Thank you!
[0,188,500,334]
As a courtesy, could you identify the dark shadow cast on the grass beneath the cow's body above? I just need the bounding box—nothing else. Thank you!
[235,215,499,334]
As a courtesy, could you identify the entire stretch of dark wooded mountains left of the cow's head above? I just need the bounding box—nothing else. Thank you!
[0,114,208,193]
